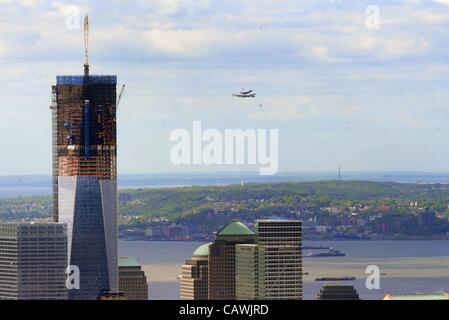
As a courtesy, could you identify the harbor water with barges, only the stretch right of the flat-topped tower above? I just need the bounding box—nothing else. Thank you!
[303,240,449,300]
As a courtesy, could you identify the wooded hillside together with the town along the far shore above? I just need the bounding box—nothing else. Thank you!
[0,181,449,241]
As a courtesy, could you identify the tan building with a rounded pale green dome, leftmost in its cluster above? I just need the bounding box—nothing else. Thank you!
[180,243,211,300]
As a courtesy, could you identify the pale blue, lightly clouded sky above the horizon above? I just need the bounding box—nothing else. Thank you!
[0,0,449,175]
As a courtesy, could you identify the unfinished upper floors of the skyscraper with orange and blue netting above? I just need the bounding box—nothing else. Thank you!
[50,76,117,219]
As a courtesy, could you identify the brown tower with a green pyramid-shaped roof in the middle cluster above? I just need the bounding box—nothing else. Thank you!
[208,221,254,300]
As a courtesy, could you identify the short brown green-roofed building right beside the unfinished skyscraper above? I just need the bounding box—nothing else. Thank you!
[118,257,148,300]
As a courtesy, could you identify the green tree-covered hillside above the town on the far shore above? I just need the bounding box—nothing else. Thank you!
[0,181,449,220]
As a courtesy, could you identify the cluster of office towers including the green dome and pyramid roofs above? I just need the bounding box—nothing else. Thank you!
[179,219,303,300]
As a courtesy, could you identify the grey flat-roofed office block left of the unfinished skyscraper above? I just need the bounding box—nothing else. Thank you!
[0,222,67,300]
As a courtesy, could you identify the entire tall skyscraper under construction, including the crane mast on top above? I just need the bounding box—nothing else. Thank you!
[51,17,118,300]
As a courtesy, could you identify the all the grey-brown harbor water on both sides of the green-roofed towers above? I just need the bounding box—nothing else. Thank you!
[119,240,449,300]
